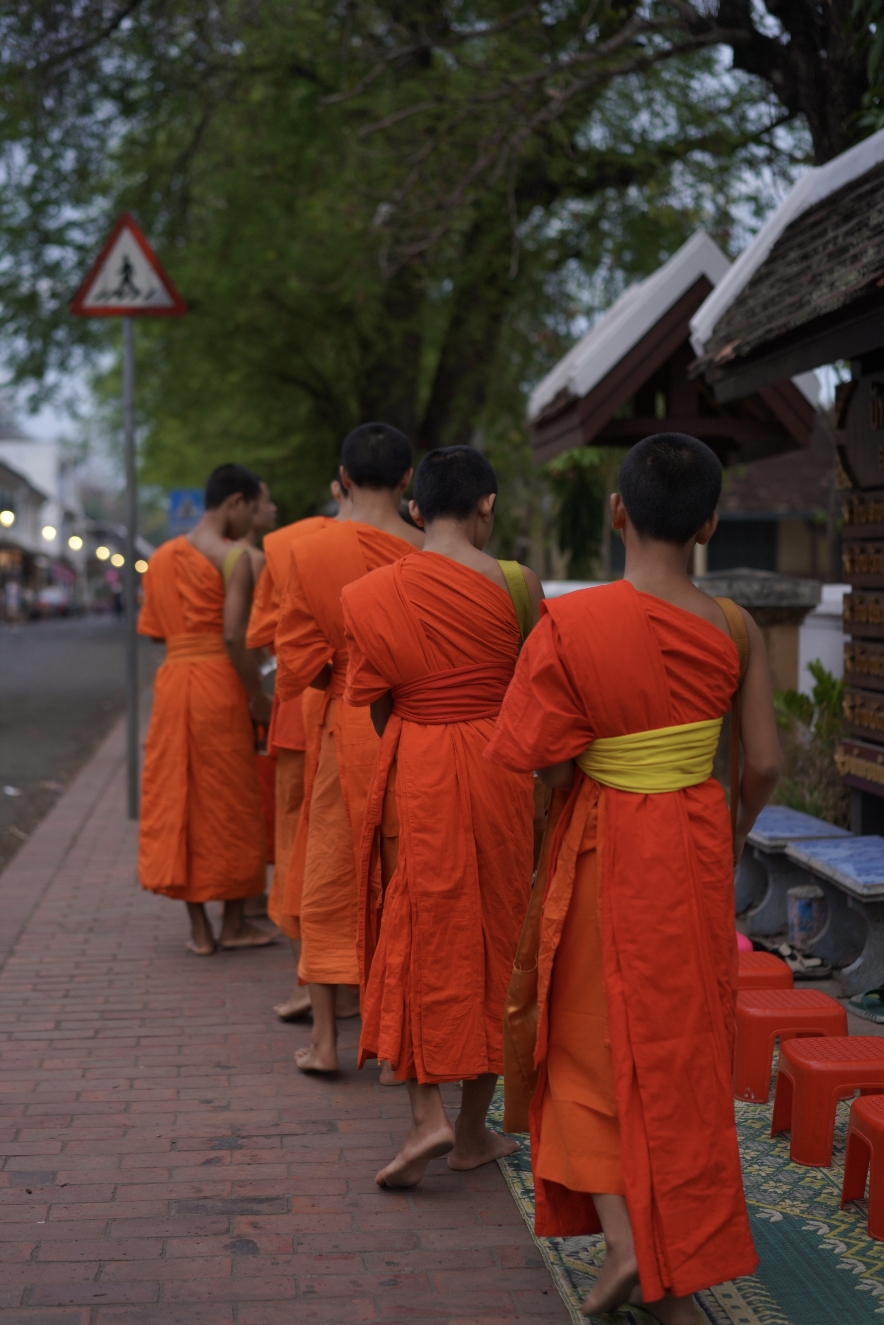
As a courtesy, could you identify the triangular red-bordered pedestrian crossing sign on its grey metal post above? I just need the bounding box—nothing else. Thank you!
[70,213,187,819]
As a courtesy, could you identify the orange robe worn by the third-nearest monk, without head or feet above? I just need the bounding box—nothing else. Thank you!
[276,521,411,984]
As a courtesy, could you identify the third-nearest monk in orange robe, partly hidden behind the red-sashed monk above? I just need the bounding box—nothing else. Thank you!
[276,423,423,1072]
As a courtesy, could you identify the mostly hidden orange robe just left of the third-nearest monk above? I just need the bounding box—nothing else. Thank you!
[245,515,333,938]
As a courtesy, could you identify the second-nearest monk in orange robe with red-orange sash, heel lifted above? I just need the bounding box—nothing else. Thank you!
[343,447,542,1187]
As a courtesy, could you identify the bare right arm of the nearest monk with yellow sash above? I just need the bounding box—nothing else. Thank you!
[734,612,783,860]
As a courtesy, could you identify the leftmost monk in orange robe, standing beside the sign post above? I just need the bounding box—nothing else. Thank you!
[138,465,273,957]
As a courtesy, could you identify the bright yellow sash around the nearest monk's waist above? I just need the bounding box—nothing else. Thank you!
[577,718,722,795]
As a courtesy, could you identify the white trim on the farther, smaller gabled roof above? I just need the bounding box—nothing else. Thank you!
[527,231,730,420]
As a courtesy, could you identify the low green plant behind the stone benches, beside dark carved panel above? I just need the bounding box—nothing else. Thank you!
[773,660,850,828]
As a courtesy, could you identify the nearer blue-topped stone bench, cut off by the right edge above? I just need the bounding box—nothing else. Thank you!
[786,833,884,994]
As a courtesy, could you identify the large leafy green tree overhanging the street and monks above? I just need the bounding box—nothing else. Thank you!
[0,0,868,543]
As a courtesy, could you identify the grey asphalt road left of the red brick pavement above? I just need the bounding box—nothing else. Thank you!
[0,616,162,869]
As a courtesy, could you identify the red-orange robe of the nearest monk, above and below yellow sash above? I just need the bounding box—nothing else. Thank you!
[486,580,757,1301]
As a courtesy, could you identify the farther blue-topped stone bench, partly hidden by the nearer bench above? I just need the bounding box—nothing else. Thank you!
[736,806,855,938]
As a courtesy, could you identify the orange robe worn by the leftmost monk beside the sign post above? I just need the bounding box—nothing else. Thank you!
[138,538,264,902]
